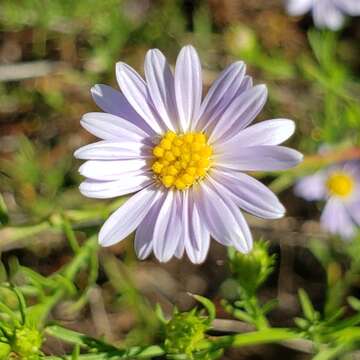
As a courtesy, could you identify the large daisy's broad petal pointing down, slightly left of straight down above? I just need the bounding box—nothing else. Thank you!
[153,190,182,262]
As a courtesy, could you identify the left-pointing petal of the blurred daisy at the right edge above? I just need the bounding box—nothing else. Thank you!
[294,171,327,201]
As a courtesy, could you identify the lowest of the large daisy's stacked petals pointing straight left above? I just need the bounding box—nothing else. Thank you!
[79,172,154,199]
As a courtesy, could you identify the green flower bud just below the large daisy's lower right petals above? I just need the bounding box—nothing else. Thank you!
[228,241,275,295]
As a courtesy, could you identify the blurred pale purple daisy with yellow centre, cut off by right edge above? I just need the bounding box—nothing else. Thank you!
[295,161,360,238]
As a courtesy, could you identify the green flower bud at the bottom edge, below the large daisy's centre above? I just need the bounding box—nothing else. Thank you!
[165,311,208,359]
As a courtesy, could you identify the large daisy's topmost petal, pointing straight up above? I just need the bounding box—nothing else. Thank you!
[175,45,202,131]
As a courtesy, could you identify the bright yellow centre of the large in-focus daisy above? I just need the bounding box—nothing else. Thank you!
[152,131,212,190]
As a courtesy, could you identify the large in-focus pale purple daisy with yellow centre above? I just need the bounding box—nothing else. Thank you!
[75,46,302,263]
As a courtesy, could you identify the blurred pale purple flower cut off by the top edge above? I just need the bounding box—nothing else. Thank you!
[287,0,360,30]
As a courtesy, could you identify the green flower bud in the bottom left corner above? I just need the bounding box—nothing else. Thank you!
[11,326,43,360]
